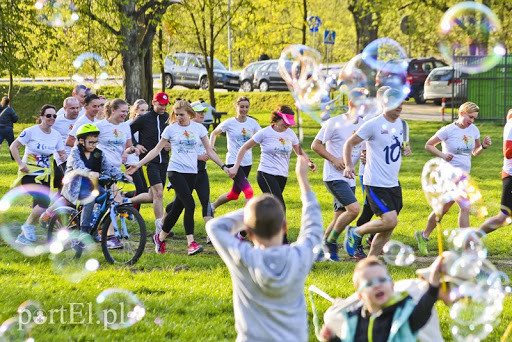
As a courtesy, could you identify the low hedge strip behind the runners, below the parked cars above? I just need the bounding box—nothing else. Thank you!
[0,84,295,123]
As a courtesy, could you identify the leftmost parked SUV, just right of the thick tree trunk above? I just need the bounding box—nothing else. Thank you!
[164,52,240,91]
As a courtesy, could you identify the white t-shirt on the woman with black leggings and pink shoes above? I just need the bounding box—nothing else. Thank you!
[162,121,208,173]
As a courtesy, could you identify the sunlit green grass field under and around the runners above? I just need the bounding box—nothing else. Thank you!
[0,113,512,341]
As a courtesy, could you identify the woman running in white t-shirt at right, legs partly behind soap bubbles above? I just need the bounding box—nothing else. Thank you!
[414,102,491,255]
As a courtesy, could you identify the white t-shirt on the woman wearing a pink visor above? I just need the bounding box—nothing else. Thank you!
[219,117,261,166]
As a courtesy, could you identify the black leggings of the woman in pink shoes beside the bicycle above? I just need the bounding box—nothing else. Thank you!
[162,171,197,235]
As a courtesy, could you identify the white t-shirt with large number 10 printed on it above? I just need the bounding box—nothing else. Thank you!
[356,115,404,188]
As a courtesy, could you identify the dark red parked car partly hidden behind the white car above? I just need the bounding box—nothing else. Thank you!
[407,57,446,103]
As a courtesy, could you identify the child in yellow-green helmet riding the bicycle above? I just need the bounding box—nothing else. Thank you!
[50,124,131,248]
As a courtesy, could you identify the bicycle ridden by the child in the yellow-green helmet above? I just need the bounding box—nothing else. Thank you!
[47,175,146,265]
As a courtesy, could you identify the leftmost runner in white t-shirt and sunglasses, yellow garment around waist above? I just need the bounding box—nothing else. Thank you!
[9,105,66,245]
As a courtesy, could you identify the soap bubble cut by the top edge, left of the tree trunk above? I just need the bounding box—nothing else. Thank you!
[35,0,80,27]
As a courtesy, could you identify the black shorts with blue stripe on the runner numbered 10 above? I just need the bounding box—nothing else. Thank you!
[364,185,403,216]
